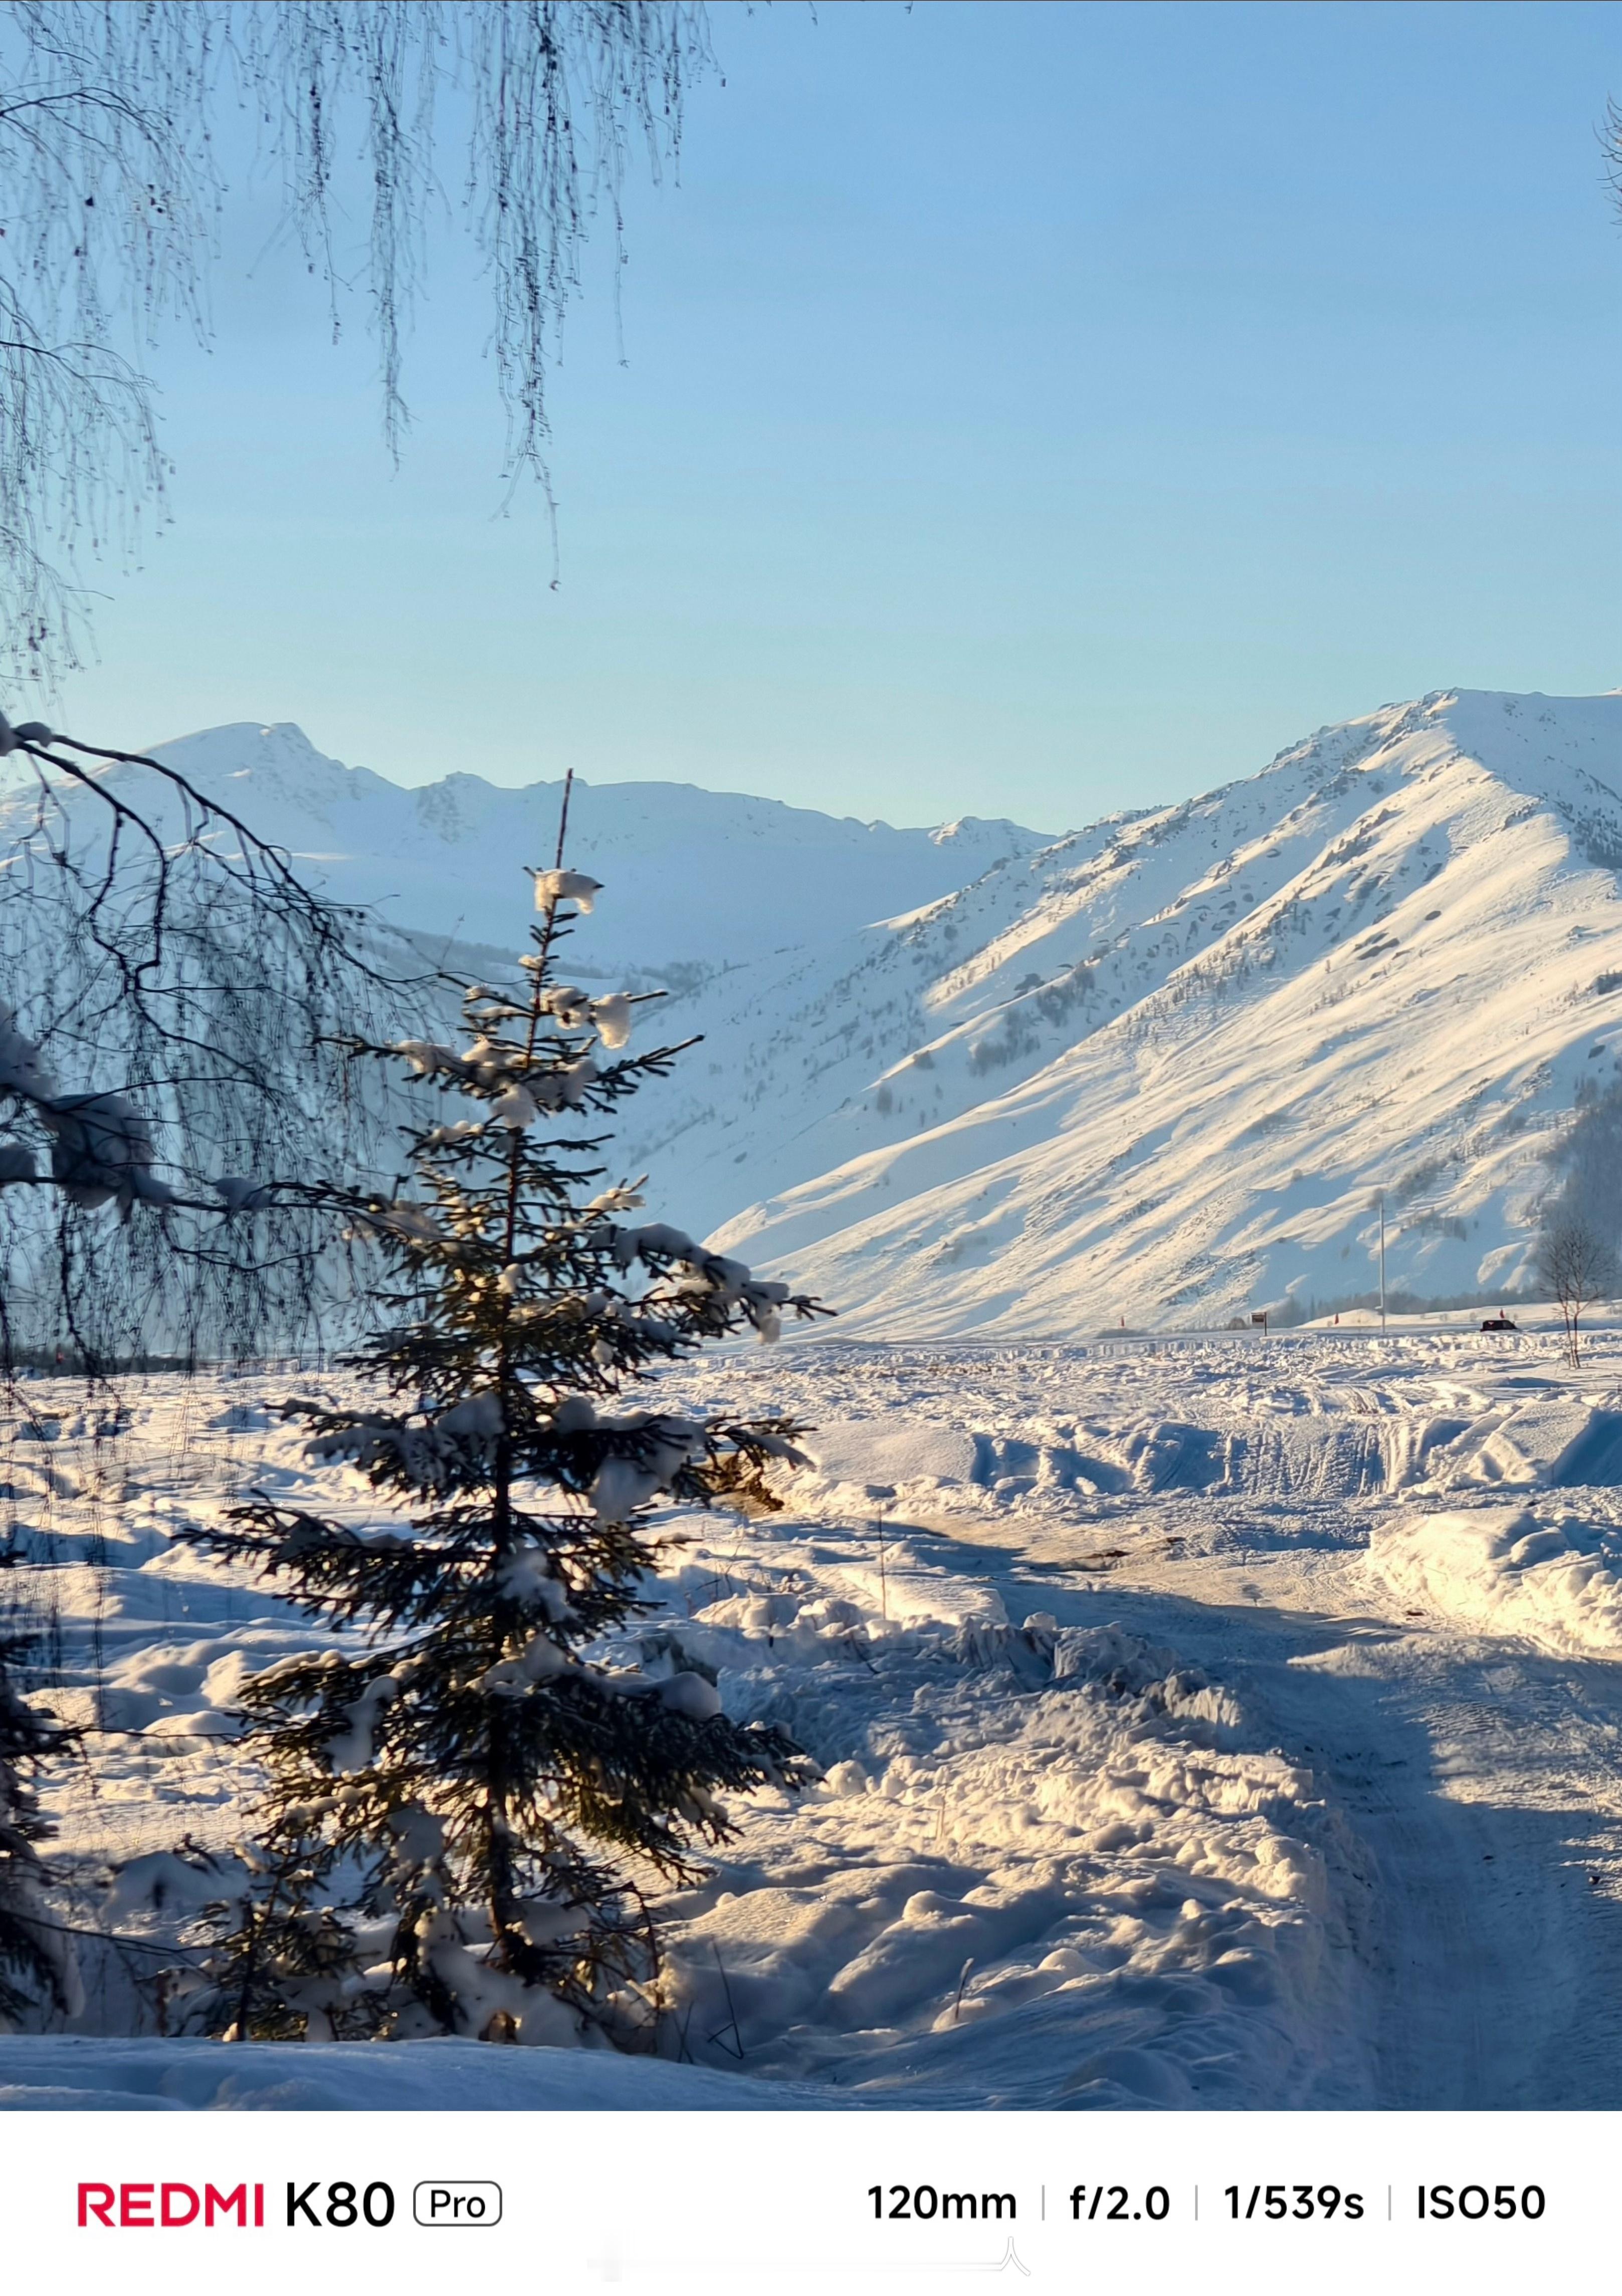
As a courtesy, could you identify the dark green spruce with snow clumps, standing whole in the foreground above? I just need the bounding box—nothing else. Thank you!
[181,826,820,2041]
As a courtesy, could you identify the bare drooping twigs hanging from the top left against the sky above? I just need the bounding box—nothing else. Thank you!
[0,0,710,687]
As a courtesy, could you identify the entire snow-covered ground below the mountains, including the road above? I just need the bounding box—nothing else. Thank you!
[0,1332,1622,2110]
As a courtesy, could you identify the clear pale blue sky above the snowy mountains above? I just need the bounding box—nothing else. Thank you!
[44,0,1622,829]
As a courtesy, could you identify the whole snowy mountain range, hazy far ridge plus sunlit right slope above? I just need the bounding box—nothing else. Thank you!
[16,693,1622,1336]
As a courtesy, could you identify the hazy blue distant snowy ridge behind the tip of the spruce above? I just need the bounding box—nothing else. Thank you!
[0,726,1046,973]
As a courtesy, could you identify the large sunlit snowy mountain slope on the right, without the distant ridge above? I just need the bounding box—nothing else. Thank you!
[675,693,1622,1339]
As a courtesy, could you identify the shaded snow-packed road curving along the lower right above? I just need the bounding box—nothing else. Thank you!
[928,1524,1622,2110]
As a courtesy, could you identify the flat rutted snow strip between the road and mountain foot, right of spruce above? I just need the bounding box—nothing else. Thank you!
[774,1327,1622,1520]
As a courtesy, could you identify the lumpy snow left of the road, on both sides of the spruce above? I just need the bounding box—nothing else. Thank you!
[0,1380,1346,2106]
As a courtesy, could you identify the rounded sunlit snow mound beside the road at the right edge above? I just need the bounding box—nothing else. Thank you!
[1369,1506,1622,1657]
